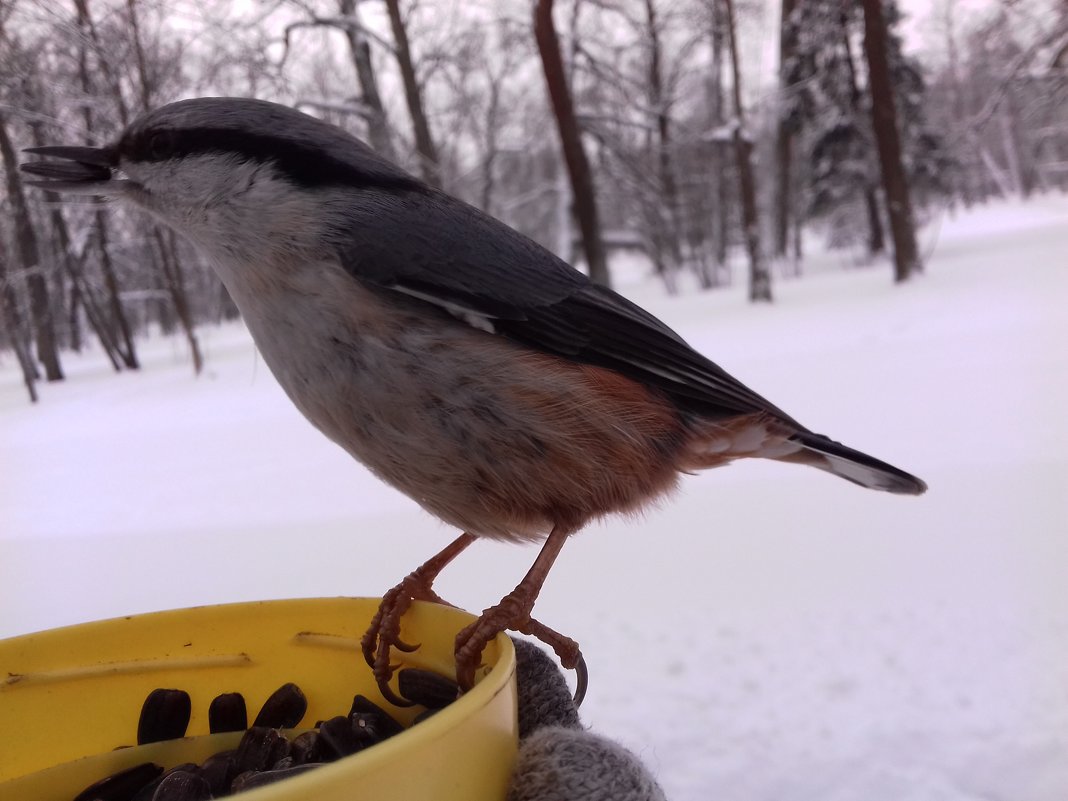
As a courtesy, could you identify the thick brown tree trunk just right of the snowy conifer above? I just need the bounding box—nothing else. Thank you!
[863,0,923,282]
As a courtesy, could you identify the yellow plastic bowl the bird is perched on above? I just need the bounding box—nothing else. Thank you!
[0,598,518,801]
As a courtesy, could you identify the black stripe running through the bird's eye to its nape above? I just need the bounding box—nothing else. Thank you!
[119,128,425,190]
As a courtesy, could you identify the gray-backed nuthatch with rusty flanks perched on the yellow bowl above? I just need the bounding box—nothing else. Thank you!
[21,97,927,703]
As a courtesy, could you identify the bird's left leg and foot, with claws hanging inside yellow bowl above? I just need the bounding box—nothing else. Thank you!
[360,532,477,706]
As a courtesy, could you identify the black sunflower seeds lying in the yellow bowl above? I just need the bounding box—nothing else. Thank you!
[74,668,459,801]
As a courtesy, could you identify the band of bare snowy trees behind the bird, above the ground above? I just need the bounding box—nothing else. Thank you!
[0,0,1068,397]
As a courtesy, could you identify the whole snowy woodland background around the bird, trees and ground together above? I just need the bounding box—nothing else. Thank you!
[6,0,1068,801]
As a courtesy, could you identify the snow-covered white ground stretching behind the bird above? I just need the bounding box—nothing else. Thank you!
[0,199,1068,801]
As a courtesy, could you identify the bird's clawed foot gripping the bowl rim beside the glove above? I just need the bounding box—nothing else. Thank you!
[456,587,587,704]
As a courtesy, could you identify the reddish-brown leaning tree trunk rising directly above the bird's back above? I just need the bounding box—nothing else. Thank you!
[534,0,610,286]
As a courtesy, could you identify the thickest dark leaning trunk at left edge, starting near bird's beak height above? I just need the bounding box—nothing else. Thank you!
[0,113,63,381]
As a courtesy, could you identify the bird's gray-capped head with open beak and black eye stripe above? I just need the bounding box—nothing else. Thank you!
[21,97,423,267]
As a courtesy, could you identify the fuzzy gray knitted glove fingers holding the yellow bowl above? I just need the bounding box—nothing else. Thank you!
[507,638,666,801]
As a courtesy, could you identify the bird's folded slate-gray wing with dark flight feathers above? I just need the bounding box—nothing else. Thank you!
[339,190,804,430]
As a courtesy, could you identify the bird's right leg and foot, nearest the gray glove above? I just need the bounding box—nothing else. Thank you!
[456,527,584,690]
